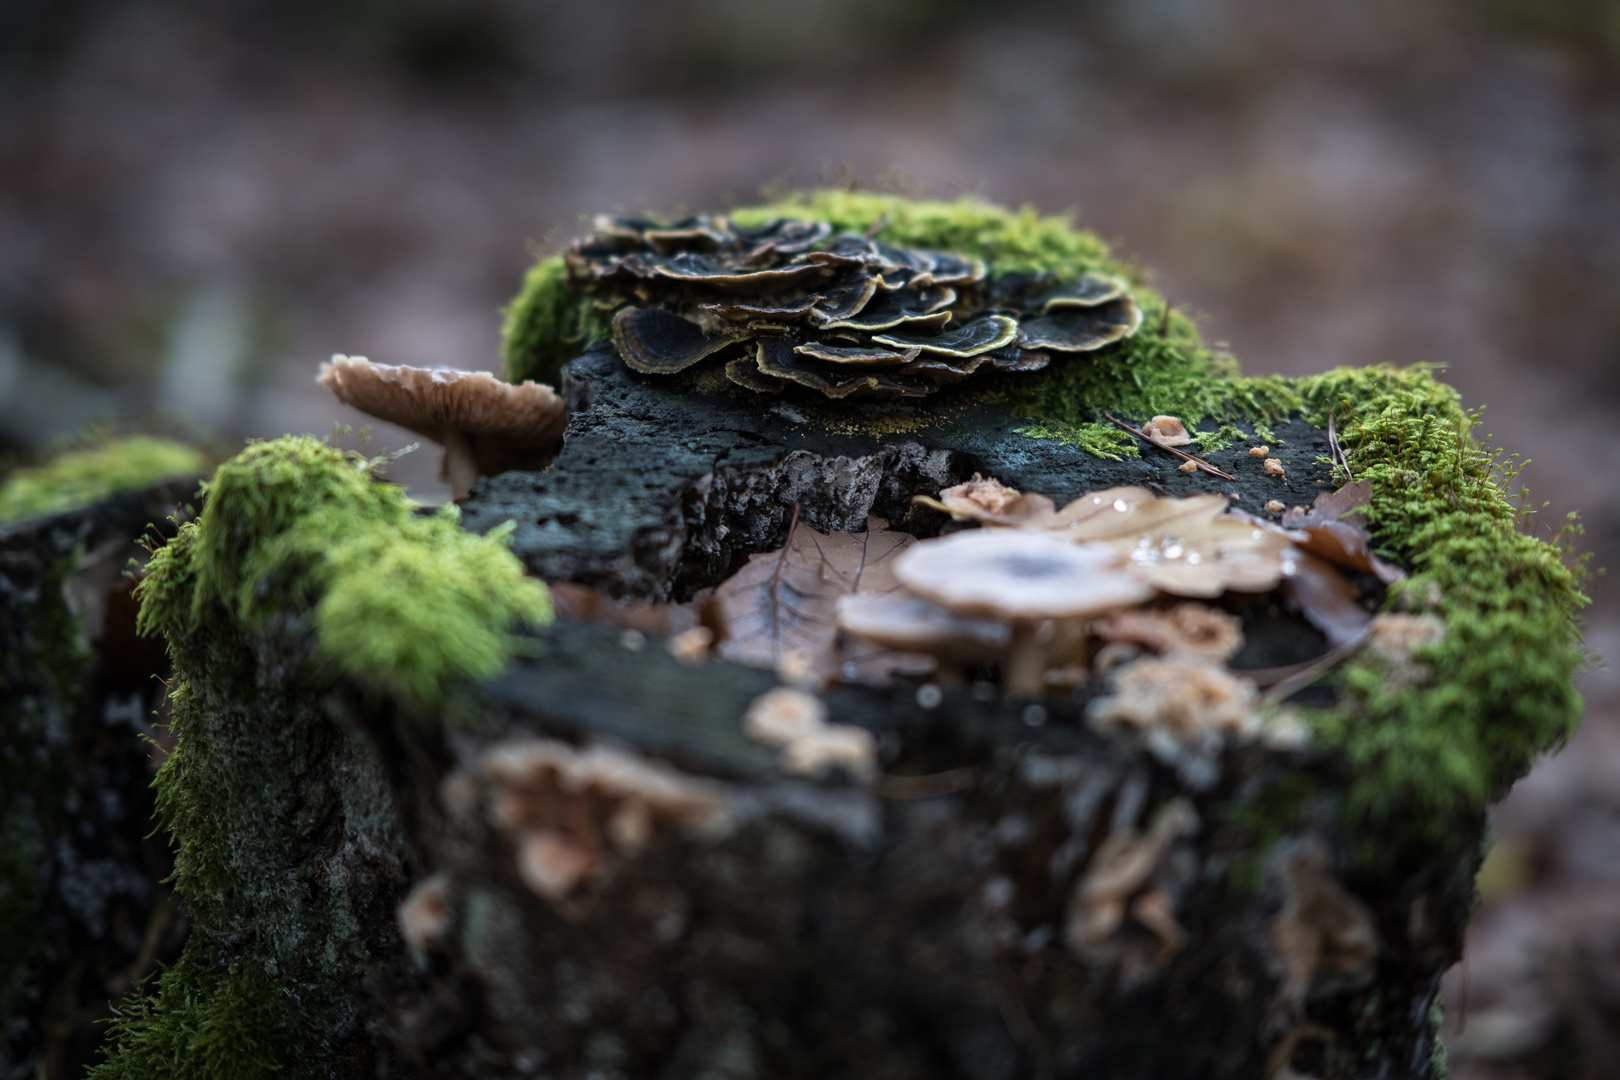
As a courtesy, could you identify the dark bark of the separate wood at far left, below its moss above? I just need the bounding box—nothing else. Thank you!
[0,483,194,1080]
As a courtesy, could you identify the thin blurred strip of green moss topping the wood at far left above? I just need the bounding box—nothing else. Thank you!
[0,436,207,523]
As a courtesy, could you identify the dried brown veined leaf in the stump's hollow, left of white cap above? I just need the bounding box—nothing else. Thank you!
[713,518,915,678]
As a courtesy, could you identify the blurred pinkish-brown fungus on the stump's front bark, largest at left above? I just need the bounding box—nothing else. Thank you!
[481,738,732,902]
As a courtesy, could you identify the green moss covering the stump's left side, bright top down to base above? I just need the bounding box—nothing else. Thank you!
[96,437,551,1080]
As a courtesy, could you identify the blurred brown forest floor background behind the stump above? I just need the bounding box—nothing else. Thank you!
[0,0,1620,1077]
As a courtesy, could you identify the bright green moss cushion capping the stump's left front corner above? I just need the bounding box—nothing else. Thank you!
[138,437,551,703]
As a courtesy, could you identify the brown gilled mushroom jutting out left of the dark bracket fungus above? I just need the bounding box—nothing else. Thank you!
[316,356,567,499]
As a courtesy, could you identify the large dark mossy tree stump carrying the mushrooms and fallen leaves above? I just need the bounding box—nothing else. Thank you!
[12,194,1581,1080]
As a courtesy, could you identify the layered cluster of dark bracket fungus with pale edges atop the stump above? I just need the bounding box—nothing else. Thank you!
[567,215,1142,398]
